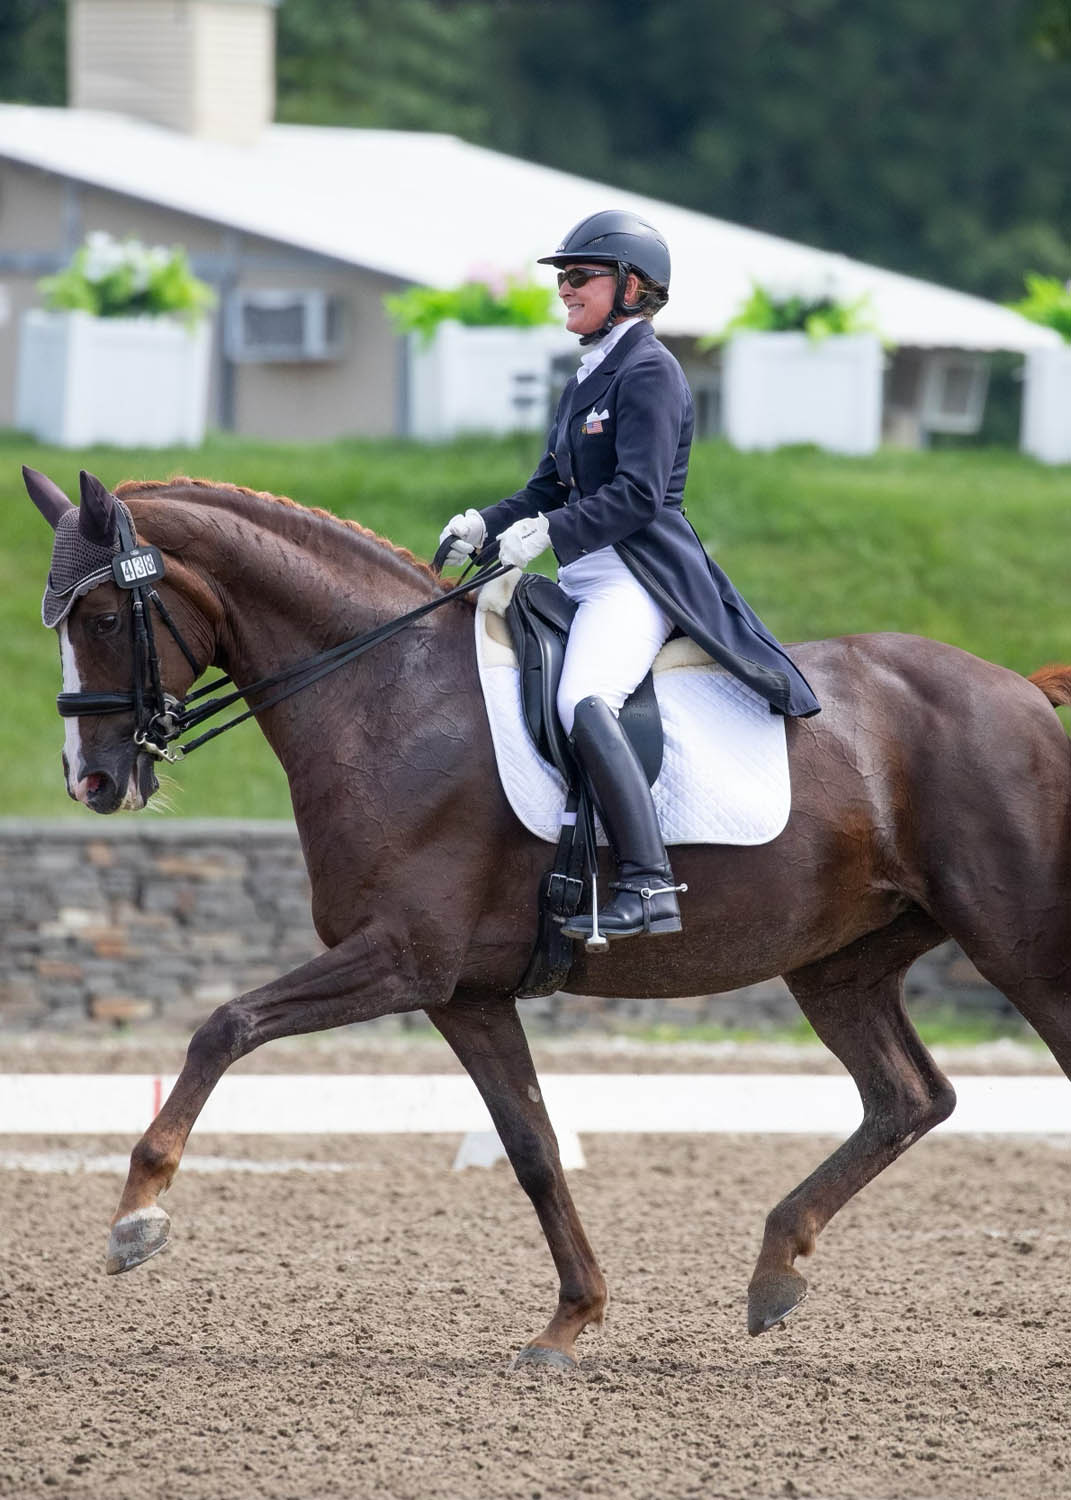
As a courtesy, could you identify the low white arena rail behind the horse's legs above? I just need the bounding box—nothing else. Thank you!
[0,1073,1071,1145]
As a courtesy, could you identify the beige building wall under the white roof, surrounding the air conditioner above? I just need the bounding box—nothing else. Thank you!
[0,161,404,441]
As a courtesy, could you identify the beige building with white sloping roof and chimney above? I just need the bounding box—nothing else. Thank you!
[0,0,1059,438]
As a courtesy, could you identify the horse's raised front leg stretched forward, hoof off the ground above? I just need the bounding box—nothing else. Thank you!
[107,924,428,1275]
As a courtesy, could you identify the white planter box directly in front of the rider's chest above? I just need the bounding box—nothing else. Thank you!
[408,323,578,441]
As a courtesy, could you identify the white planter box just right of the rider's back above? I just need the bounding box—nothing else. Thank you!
[723,333,885,453]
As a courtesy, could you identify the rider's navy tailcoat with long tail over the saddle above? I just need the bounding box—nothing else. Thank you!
[480,323,821,717]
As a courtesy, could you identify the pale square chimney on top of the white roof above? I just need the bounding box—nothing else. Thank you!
[68,0,279,144]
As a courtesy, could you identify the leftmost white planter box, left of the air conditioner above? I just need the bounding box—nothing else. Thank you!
[15,309,210,449]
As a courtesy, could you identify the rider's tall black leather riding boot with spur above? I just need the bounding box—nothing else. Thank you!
[561,698,687,939]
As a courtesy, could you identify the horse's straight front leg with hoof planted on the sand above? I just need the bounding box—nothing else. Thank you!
[431,993,606,1368]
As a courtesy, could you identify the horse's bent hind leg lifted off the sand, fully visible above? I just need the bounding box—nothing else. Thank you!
[747,912,956,1334]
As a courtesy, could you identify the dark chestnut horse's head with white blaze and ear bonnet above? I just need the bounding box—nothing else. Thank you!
[23,468,210,813]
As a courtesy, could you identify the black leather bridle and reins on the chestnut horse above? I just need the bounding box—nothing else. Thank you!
[56,528,509,761]
